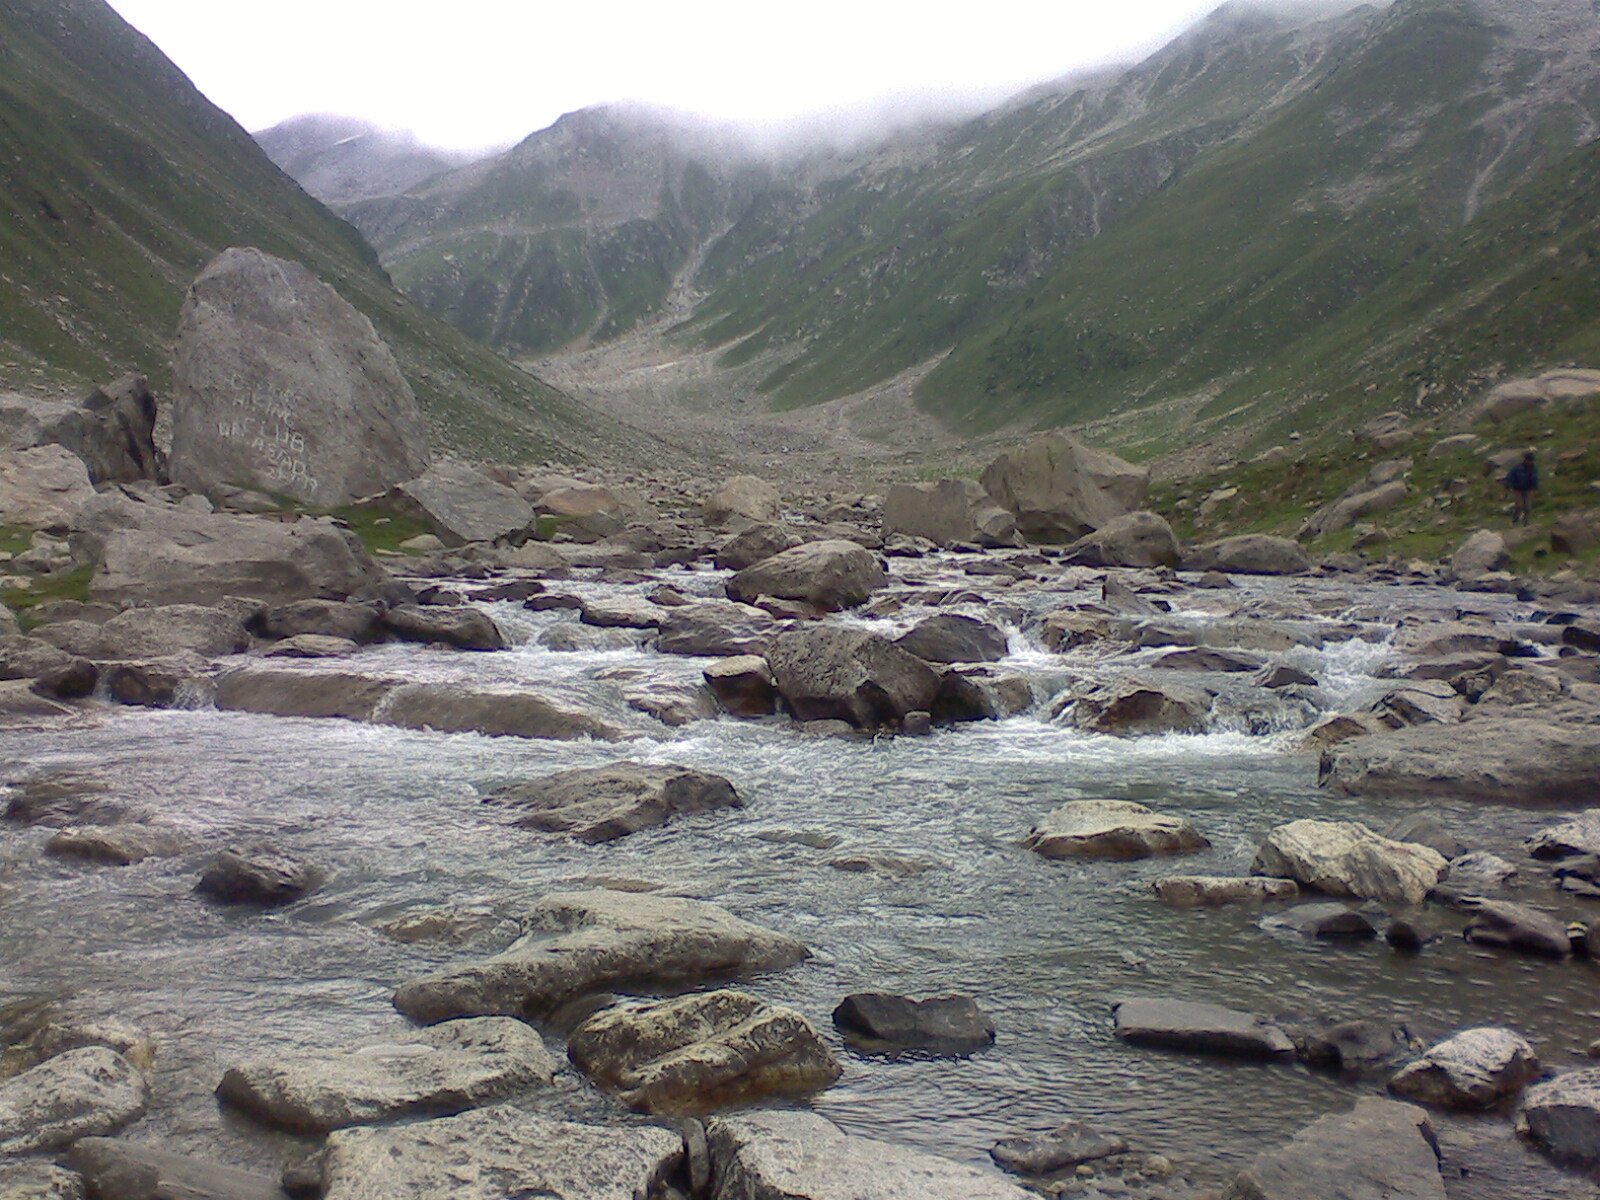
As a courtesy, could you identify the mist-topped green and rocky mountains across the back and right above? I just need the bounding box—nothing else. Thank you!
[324,0,1600,456]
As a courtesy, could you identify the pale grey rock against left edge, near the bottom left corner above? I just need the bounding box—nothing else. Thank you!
[0,1046,147,1154]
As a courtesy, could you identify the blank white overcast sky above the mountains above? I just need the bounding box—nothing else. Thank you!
[110,0,1221,149]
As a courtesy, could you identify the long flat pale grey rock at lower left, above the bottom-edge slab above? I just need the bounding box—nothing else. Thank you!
[216,1016,555,1133]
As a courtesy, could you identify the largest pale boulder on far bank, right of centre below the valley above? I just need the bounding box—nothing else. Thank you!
[981,432,1150,542]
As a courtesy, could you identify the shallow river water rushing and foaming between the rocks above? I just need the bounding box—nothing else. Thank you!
[0,562,1600,1200]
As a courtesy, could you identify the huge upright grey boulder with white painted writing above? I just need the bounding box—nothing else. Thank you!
[170,248,429,509]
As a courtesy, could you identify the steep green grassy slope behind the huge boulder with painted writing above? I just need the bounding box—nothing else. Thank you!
[0,0,614,458]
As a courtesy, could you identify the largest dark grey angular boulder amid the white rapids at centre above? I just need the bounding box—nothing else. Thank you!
[766,626,939,730]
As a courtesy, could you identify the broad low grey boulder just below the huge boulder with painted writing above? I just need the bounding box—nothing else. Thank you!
[74,493,386,605]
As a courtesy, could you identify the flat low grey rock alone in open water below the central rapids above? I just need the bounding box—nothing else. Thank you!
[486,763,744,845]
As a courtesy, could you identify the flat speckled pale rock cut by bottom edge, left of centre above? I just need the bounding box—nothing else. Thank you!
[323,1106,683,1200]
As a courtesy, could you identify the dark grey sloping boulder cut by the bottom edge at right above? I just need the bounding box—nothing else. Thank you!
[1222,1099,1445,1200]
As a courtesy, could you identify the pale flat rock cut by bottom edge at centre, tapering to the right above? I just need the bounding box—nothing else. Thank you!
[707,1112,1034,1200]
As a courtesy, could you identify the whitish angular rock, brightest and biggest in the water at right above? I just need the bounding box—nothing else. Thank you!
[1251,821,1446,904]
